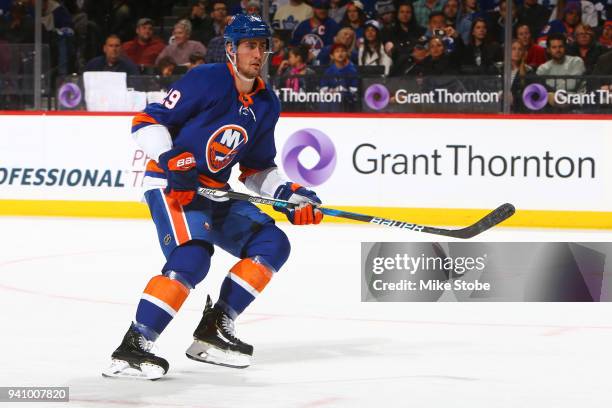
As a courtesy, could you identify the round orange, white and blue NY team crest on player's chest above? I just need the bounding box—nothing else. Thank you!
[206,125,249,173]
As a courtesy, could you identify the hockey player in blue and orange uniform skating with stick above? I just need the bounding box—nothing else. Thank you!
[103,14,323,380]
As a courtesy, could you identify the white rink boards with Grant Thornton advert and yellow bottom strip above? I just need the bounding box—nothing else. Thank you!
[0,113,612,229]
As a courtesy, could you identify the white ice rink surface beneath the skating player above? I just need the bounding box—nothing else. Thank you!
[0,218,612,408]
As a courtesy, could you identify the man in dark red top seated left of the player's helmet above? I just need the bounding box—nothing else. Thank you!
[121,17,166,67]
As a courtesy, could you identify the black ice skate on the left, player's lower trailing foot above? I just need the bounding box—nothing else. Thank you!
[102,325,169,380]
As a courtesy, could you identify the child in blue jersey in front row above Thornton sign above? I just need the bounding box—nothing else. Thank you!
[321,43,359,102]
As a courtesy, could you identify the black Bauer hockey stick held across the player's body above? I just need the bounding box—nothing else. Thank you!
[198,187,515,239]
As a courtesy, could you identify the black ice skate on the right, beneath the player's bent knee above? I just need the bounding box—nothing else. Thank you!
[186,296,253,368]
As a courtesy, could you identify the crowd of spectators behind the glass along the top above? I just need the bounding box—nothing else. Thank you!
[0,0,612,108]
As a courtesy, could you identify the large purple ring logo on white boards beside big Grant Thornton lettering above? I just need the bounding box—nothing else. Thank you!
[282,129,336,187]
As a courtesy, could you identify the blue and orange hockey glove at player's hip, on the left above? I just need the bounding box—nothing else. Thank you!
[158,147,199,206]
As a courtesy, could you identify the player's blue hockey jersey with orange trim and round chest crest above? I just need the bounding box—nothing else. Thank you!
[132,64,280,187]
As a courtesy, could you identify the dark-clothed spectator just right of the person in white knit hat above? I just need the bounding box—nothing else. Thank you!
[381,3,425,60]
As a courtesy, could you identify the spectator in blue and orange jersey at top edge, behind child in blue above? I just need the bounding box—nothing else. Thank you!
[291,0,340,56]
